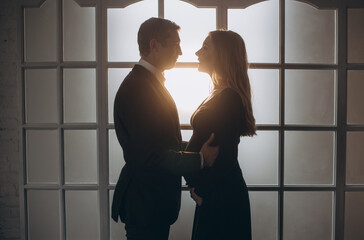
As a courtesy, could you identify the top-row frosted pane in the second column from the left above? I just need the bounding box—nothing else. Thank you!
[63,0,96,61]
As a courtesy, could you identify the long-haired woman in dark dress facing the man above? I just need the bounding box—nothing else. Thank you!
[185,30,256,240]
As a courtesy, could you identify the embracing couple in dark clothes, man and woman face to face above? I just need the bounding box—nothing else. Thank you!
[112,18,256,240]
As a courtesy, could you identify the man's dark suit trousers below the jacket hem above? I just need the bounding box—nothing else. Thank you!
[125,224,170,240]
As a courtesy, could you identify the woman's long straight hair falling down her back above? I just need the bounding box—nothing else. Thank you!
[209,30,256,136]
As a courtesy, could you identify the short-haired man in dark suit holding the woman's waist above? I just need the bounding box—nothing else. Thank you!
[112,18,218,240]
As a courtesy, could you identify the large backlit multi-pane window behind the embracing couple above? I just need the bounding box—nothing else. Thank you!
[19,0,364,240]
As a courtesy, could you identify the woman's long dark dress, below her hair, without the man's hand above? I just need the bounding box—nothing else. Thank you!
[185,88,251,240]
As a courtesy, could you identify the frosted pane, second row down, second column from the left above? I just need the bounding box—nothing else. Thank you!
[63,69,96,123]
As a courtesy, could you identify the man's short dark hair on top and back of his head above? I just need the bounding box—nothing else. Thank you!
[138,17,180,56]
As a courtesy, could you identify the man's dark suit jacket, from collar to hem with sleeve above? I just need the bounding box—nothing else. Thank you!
[112,65,200,226]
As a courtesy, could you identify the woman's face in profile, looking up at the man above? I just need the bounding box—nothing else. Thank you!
[195,36,215,75]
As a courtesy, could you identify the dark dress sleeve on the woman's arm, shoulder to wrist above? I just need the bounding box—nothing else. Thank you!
[187,89,243,197]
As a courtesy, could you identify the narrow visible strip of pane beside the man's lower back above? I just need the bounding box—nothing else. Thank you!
[109,129,125,184]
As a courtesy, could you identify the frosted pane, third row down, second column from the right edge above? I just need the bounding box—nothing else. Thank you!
[284,131,335,185]
